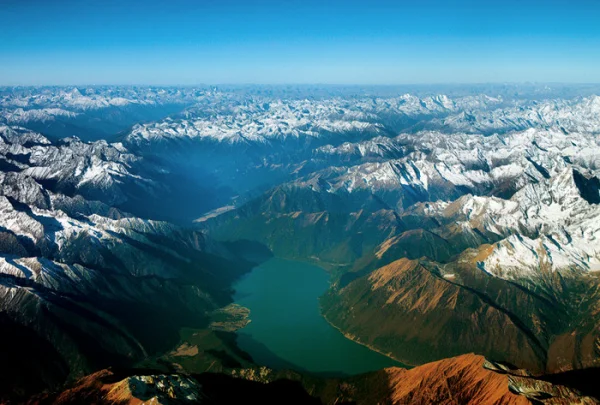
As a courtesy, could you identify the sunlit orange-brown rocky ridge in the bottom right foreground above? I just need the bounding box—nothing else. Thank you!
[316,353,600,405]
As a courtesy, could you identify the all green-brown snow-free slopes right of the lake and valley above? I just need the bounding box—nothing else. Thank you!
[203,167,600,373]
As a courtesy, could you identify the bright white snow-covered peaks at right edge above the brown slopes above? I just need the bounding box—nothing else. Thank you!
[408,168,600,281]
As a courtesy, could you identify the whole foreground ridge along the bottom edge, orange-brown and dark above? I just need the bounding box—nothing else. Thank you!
[29,354,600,405]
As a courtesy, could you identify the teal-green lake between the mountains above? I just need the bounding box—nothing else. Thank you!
[234,258,400,375]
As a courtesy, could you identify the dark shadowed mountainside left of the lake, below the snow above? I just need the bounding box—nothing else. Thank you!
[0,221,262,399]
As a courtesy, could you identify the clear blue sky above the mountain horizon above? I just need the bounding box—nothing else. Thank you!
[0,0,600,85]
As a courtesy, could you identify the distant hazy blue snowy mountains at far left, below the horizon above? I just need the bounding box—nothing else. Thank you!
[0,87,205,140]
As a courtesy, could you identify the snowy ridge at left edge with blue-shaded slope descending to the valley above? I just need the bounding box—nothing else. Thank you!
[0,126,228,223]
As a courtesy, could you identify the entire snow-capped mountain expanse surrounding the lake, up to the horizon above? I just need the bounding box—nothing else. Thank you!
[0,85,600,398]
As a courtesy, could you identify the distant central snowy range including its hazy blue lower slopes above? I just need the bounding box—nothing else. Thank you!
[121,89,501,216]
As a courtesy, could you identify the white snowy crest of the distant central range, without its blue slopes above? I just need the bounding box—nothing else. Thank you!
[126,94,501,144]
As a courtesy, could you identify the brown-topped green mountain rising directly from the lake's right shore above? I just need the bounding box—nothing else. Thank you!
[322,259,546,371]
